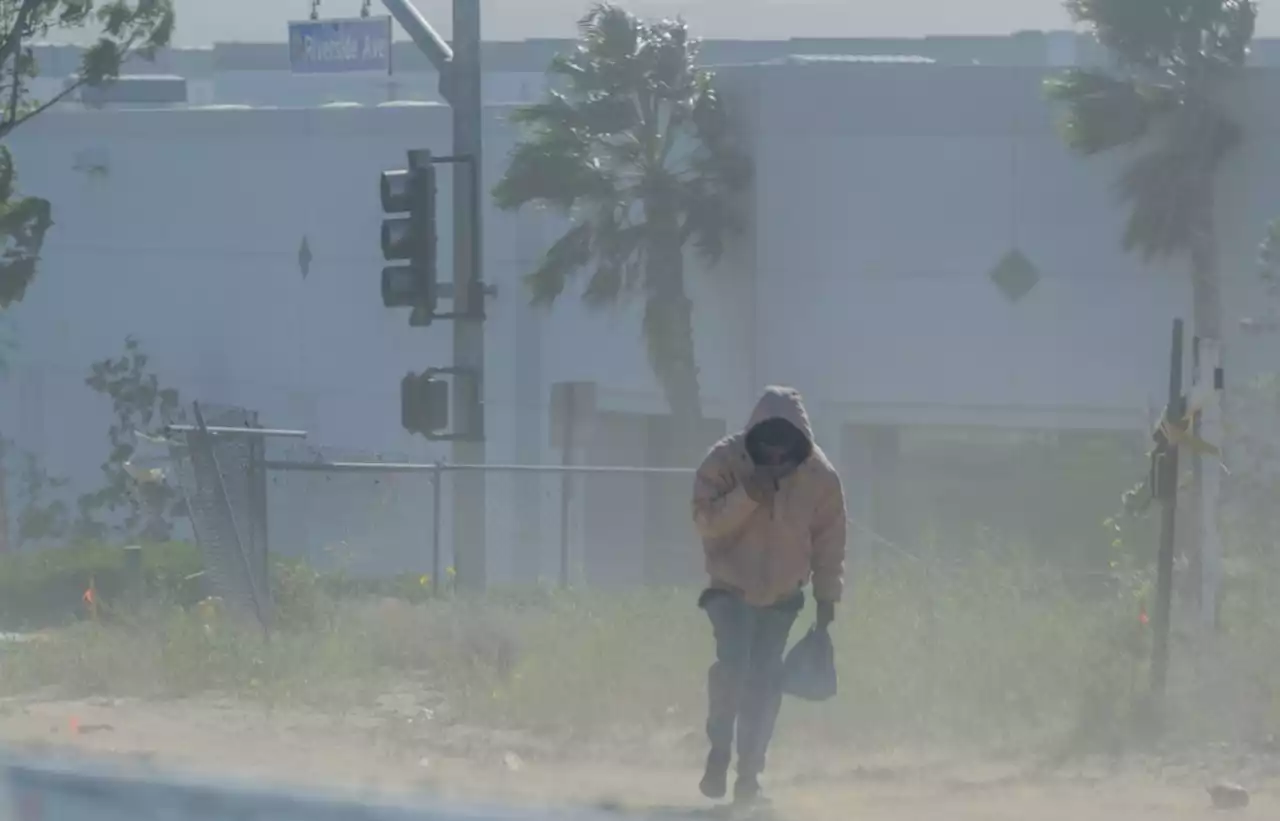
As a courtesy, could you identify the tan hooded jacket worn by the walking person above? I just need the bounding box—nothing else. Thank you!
[692,387,845,607]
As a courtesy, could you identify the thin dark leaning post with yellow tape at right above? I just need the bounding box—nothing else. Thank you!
[1151,319,1183,698]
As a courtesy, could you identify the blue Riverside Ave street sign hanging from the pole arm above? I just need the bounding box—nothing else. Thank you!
[289,17,392,74]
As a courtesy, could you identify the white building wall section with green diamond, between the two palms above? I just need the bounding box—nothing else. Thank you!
[731,63,1275,429]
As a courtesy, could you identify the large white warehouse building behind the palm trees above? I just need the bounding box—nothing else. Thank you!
[0,60,1280,580]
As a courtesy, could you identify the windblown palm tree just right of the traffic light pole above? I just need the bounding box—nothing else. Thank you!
[494,4,750,421]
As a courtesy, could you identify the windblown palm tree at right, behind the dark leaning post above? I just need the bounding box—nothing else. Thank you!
[1046,0,1257,627]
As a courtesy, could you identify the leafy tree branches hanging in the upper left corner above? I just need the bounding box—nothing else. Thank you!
[0,0,174,310]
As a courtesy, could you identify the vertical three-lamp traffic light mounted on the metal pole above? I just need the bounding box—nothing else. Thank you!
[380,152,438,325]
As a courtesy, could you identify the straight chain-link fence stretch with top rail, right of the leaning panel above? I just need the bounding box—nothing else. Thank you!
[266,444,700,588]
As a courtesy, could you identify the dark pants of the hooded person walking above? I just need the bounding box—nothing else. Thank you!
[699,590,804,777]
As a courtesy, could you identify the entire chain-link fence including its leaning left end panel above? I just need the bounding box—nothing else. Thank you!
[168,406,701,612]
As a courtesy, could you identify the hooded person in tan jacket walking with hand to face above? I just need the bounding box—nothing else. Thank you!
[692,387,846,803]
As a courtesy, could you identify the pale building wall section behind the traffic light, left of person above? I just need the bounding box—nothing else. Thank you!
[0,99,742,579]
